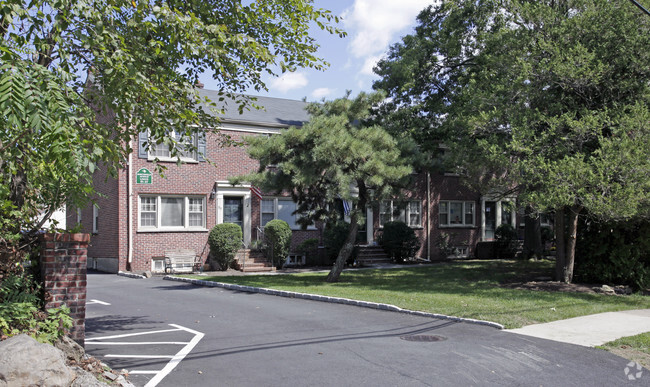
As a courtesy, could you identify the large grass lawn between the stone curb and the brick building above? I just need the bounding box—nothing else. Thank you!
[185,260,650,328]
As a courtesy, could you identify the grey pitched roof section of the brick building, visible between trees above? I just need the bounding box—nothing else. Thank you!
[199,89,309,127]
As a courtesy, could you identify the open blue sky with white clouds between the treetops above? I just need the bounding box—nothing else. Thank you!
[197,0,435,101]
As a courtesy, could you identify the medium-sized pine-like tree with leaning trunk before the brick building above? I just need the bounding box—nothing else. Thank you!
[239,93,415,282]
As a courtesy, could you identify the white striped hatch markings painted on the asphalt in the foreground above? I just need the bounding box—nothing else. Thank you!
[86,324,205,387]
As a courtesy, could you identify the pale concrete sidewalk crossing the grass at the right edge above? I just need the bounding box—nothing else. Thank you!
[505,309,650,347]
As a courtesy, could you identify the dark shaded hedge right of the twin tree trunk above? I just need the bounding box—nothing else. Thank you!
[575,219,650,290]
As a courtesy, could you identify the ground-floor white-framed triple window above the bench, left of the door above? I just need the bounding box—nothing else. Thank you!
[138,195,206,231]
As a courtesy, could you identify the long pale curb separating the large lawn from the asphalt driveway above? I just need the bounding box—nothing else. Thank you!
[163,275,503,329]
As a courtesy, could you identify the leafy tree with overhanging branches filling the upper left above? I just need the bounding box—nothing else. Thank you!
[0,0,345,266]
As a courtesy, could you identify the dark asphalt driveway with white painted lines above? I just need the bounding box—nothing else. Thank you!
[86,273,650,386]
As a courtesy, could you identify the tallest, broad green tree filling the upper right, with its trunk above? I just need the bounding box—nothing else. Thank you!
[375,0,650,282]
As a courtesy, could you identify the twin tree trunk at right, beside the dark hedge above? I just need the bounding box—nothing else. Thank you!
[555,205,582,284]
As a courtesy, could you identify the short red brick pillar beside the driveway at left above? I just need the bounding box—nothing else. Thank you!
[41,234,90,346]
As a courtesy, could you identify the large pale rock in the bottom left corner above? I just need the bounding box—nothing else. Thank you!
[0,335,76,386]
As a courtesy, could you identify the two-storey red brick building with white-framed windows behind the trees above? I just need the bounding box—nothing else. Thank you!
[67,90,515,272]
